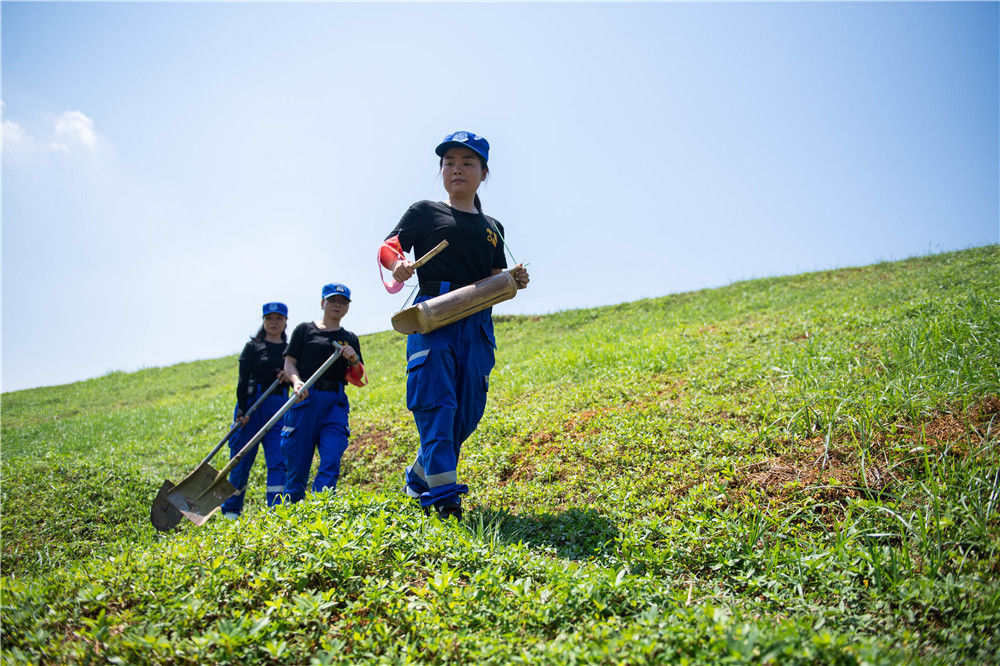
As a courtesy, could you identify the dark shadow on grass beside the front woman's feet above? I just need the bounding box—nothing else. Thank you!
[465,507,619,560]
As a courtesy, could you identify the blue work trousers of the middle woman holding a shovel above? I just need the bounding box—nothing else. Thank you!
[281,385,351,502]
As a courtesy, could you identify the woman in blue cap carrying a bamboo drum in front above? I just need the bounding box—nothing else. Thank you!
[379,132,529,519]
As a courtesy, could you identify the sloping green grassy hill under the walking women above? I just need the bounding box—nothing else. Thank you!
[0,246,1000,664]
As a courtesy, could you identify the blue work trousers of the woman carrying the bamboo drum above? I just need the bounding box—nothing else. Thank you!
[406,308,496,507]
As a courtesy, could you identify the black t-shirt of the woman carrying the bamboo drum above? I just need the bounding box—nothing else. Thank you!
[386,201,507,285]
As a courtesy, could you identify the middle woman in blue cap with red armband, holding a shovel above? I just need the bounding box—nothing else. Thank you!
[281,283,367,502]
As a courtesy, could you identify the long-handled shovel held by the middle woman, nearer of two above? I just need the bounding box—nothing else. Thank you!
[167,342,342,525]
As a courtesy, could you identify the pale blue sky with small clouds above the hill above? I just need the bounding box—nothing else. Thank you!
[0,2,1000,391]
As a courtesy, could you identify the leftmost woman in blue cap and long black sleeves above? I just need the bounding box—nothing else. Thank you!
[222,303,288,519]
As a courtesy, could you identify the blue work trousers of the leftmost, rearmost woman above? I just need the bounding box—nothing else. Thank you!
[222,395,286,514]
